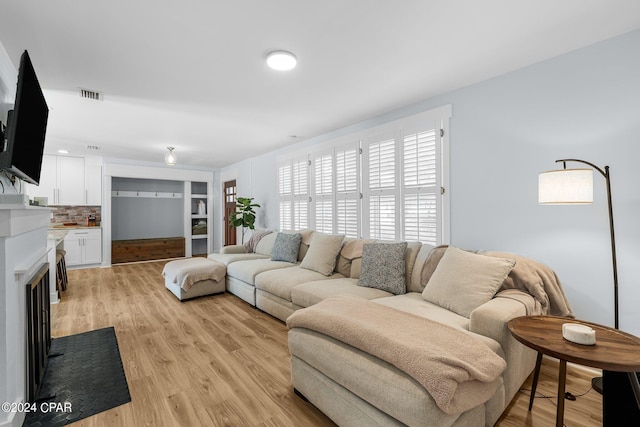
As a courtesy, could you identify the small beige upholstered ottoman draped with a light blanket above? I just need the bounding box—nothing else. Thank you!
[162,258,227,301]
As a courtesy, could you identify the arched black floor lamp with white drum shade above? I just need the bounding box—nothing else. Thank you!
[538,159,640,401]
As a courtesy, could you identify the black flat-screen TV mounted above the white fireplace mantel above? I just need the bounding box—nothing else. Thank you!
[0,50,49,185]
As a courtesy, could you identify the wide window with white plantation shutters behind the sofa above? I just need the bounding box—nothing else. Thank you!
[278,105,451,245]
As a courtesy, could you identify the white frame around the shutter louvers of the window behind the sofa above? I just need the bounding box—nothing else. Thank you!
[277,105,452,245]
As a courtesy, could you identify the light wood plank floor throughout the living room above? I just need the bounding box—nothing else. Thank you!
[52,262,602,427]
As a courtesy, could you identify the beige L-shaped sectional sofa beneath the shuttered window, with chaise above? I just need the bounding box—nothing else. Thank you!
[209,230,572,426]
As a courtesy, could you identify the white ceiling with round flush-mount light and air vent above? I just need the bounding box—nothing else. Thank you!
[0,0,640,168]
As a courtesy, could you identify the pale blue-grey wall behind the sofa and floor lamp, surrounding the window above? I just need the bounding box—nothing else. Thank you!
[222,31,640,335]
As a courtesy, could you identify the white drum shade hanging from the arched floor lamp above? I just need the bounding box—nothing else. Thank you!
[538,169,593,205]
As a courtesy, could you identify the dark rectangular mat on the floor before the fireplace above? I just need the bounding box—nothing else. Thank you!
[23,327,131,427]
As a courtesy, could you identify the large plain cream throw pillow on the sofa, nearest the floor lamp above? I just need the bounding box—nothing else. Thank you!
[422,246,515,317]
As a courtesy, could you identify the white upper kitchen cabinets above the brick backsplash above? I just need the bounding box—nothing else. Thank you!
[27,154,102,206]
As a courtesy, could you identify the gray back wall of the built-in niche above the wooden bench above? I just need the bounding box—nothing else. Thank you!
[111,178,184,240]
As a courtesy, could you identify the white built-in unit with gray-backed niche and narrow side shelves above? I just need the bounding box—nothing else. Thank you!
[102,162,214,266]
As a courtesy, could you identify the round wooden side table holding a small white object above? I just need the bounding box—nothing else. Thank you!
[508,316,640,427]
